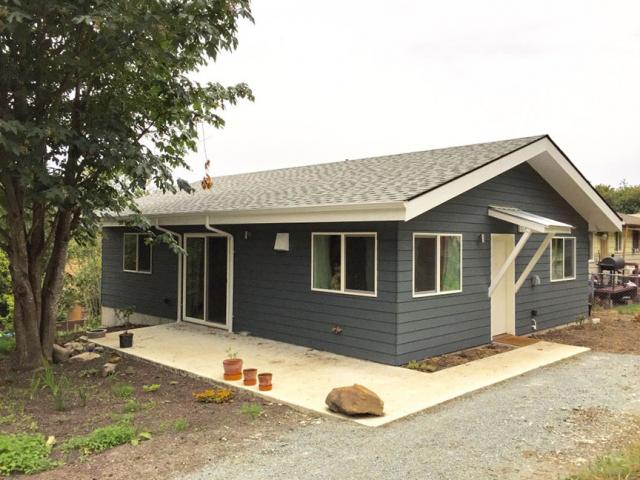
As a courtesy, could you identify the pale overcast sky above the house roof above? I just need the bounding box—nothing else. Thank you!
[178,0,640,185]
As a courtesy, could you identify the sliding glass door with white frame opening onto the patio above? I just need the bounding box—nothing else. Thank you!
[183,234,229,325]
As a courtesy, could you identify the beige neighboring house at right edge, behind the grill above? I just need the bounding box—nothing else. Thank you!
[589,213,640,273]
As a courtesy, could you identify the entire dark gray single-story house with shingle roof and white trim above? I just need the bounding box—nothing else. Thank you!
[102,136,621,364]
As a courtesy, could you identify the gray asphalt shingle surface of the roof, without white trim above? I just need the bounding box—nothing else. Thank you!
[138,136,543,215]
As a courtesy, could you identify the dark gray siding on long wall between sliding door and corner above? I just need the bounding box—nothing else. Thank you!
[221,222,397,363]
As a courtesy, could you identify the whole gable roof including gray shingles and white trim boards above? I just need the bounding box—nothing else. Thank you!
[106,135,620,233]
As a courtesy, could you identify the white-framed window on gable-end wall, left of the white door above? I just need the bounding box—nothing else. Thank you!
[413,232,462,297]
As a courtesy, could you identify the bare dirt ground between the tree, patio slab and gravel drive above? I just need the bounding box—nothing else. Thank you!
[0,344,321,480]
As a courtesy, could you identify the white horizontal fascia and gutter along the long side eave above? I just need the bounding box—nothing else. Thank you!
[102,202,405,227]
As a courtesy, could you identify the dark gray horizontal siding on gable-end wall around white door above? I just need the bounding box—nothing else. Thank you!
[396,164,588,362]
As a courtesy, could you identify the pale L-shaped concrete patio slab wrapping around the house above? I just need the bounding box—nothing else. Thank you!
[95,322,588,427]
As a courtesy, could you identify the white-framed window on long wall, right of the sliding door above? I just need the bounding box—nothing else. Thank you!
[311,232,378,297]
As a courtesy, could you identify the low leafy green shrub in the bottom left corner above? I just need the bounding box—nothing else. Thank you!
[0,433,58,475]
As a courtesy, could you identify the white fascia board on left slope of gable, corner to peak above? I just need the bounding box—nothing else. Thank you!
[404,139,546,221]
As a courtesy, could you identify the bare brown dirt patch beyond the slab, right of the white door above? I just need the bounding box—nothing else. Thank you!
[535,310,640,355]
